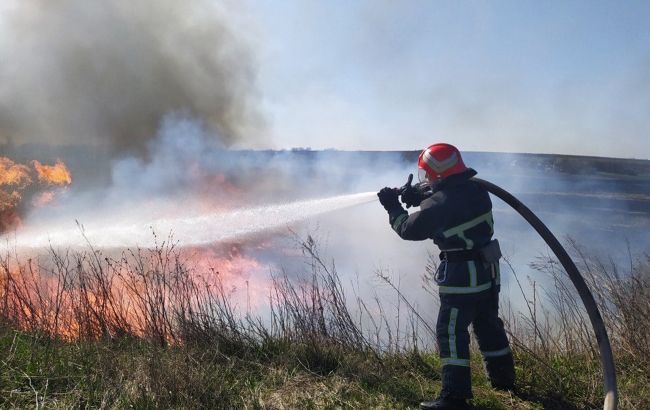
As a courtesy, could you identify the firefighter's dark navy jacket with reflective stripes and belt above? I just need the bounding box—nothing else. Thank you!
[388,168,499,294]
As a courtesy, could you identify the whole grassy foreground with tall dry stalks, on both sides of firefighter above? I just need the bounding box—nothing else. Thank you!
[0,238,650,409]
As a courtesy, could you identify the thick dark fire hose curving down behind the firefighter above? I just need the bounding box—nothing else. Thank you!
[398,174,618,410]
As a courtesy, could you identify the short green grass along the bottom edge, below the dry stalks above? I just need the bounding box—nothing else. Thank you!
[0,329,541,409]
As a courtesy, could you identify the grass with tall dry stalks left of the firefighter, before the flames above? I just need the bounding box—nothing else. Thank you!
[0,232,435,408]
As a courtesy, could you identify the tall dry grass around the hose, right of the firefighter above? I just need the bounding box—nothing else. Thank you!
[503,239,650,409]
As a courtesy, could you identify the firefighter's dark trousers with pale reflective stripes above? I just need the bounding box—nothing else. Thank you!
[436,291,515,398]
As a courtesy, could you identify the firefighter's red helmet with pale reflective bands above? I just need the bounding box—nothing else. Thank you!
[418,144,467,181]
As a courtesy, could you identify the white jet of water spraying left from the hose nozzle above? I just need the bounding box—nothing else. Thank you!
[0,192,377,249]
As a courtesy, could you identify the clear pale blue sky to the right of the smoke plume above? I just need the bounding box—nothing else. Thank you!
[241,0,650,158]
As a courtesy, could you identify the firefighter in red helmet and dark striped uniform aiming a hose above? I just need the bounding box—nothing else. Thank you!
[377,143,515,409]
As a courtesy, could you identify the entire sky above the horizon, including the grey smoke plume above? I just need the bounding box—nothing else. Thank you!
[0,0,650,159]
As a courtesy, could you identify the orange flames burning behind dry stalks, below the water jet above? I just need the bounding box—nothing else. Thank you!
[0,244,272,343]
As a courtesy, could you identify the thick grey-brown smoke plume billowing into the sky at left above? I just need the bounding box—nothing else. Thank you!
[0,0,260,155]
